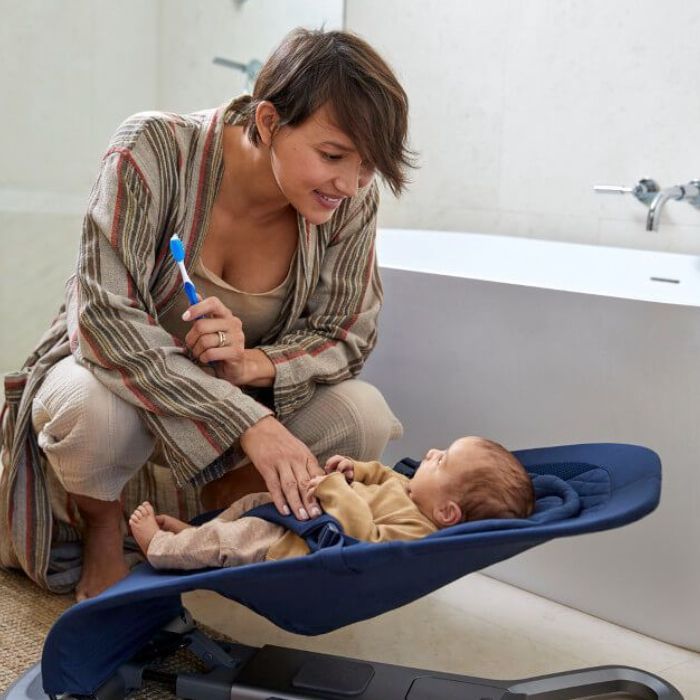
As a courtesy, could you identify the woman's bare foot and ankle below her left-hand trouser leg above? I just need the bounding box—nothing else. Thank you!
[73,494,129,602]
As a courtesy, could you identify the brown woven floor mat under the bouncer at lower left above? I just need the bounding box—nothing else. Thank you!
[0,569,232,700]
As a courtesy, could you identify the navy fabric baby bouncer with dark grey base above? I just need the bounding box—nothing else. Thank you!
[6,444,682,700]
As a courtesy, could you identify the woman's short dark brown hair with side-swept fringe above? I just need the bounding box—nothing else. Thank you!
[243,28,415,196]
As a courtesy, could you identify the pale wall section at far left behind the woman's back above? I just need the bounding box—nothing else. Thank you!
[0,0,158,372]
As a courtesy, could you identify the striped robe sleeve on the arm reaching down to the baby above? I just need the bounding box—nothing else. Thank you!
[68,125,270,484]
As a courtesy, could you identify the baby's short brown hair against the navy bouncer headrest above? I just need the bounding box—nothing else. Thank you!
[456,438,535,522]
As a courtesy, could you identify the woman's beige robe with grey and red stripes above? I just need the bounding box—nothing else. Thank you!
[0,96,382,592]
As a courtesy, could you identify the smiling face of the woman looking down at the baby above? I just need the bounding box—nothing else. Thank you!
[262,102,374,225]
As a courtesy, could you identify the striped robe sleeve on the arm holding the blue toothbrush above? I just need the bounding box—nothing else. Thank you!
[260,183,383,417]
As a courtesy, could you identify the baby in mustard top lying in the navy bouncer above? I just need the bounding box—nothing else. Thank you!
[129,437,534,569]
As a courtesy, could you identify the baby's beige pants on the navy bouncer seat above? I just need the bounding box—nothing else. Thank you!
[146,493,286,570]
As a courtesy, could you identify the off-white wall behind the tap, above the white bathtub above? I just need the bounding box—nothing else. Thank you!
[347,0,700,253]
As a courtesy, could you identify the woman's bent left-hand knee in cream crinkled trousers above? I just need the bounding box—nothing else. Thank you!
[32,357,154,500]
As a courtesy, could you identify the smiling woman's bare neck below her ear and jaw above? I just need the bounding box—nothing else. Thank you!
[218,126,291,223]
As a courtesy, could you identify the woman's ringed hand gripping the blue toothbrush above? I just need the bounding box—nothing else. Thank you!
[182,297,245,385]
